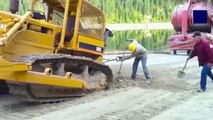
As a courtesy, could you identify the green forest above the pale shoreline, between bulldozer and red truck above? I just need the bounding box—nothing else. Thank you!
[87,0,185,23]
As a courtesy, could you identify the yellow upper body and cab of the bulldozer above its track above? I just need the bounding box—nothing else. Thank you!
[0,0,105,62]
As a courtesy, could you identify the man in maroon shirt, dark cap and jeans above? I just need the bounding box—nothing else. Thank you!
[187,32,213,92]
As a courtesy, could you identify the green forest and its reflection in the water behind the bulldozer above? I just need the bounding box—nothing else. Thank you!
[0,0,186,50]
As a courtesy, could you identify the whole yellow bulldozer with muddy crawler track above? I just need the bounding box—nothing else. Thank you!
[0,0,113,102]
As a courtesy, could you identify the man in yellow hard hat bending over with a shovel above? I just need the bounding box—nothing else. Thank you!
[117,40,151,85]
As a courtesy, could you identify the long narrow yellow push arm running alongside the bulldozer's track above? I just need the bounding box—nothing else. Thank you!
[0,71,86,89]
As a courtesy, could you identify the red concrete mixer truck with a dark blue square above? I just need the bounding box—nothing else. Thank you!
[169,0,213,54]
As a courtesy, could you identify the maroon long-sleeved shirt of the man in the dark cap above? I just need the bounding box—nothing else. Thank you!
[190,40,213,66]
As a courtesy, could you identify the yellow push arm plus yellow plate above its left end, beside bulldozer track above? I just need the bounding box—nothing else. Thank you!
[0,59,86,88]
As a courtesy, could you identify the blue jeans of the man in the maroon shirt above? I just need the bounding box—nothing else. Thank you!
[200,64,213,91]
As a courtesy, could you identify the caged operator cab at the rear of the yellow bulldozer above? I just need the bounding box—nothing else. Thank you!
[40,0,105,54]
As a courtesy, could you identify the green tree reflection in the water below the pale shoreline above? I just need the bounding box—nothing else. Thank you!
[106,30,174,50]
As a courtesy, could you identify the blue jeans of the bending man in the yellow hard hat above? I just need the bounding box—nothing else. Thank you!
[131,56,150,80]
